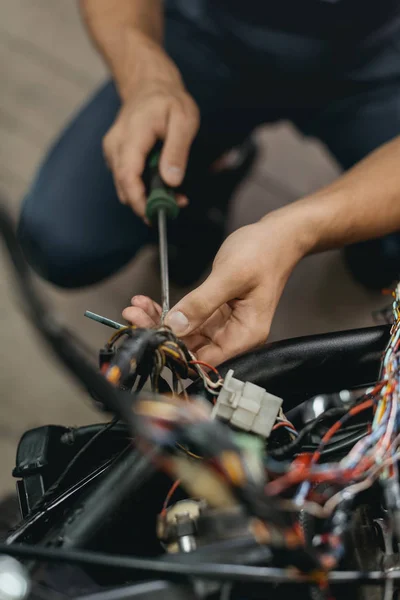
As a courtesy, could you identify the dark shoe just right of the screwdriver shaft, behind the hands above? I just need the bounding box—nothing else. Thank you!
[168,140,257,287]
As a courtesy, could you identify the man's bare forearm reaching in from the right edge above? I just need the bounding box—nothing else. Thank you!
[264,138,400,254]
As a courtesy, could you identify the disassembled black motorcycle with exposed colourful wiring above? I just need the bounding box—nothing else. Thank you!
[0,203,400,600]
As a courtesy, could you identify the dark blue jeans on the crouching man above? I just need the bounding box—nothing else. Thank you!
[19,2,400,288]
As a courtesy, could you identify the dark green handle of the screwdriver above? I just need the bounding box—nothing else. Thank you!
[146,152,179,223]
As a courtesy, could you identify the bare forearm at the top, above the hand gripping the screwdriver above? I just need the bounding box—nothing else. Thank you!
[80,0,164,96]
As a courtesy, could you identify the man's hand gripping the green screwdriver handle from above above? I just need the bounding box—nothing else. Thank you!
[103,43,200,218]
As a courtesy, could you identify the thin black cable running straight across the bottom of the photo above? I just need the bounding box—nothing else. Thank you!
[0,544,400,585]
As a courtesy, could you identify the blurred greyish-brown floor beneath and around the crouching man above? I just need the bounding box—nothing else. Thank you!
[0,0,385,492]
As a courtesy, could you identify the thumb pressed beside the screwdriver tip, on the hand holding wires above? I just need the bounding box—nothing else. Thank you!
[165,273,235,337]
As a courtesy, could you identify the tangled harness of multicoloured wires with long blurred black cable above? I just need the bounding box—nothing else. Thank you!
[0,200,400,589]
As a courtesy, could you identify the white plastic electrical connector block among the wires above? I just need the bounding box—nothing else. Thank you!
[211,370,282,438]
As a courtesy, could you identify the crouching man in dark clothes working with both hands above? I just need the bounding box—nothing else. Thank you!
[19,0,400,364]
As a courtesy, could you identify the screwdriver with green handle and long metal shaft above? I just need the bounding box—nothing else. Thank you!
[146,152,179,324]
